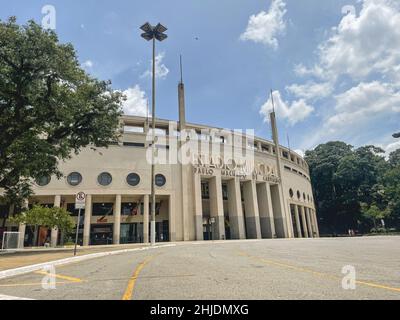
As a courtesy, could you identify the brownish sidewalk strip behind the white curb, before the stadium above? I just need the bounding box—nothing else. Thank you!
[0,243,149,271]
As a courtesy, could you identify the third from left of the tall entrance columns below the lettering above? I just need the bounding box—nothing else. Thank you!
[243,181,261,239]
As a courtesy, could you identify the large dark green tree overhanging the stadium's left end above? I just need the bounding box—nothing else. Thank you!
[0,18,123,203]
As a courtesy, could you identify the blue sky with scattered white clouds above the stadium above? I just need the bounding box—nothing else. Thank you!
[0,0,400,155]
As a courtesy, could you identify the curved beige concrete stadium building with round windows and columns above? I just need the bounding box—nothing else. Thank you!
[0,79,319,247]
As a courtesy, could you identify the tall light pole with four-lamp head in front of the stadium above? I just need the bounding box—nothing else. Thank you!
[140,22,168,246]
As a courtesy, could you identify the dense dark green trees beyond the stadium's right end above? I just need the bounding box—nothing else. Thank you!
[306,142,400,233]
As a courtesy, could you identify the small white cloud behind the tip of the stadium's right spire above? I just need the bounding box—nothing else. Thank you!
[260,91,314,125]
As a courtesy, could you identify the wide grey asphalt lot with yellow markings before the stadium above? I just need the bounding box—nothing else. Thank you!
[0,237,400,300]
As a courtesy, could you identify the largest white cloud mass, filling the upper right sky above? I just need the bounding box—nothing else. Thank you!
[286,0,400,147]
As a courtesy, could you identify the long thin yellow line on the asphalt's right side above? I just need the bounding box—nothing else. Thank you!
[239,252,400,292]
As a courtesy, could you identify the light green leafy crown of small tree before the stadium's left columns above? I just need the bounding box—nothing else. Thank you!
[10,205,75,233]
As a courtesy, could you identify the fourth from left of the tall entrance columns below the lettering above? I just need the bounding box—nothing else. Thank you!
[257,182,276,239]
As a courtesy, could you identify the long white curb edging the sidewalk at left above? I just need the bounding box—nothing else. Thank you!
[0,244,176,280]
